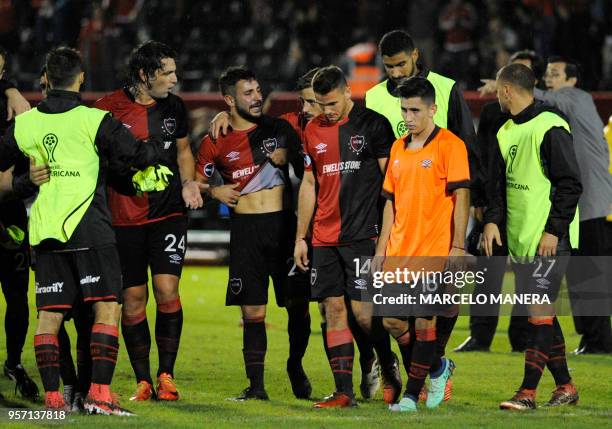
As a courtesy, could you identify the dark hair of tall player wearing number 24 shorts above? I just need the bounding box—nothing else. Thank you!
[127,40,176,88]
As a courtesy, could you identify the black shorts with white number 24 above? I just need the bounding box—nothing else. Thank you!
[115,216,187,288]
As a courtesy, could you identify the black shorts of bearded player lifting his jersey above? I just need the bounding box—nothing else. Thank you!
[225,211,308,307]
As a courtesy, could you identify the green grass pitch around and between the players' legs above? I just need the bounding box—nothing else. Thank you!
[0,267,612,429]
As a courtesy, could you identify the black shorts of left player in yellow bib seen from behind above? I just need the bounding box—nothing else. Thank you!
[35,246,122,311]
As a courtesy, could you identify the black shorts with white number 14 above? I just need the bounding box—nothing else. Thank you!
[310,239,376,301]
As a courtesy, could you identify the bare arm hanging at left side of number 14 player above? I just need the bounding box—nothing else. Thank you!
[293,171,317,271]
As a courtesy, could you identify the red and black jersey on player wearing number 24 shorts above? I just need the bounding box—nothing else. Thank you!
[94,88,189,226]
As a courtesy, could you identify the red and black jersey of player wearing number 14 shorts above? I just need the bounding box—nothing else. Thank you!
[304,105,395,246]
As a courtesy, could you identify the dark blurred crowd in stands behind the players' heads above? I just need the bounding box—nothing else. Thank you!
[0,0,612,91]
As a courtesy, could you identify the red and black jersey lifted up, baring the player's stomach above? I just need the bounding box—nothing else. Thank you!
[197,116,300,195]
